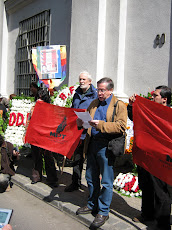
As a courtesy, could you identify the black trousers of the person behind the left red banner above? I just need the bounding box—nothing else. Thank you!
[31,145,58,183]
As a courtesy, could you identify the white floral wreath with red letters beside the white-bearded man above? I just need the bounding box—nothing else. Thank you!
[51,85,78,108]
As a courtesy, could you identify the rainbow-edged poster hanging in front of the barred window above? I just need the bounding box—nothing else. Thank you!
[32,45,66,89]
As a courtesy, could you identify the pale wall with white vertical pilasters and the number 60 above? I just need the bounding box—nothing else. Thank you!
[69,0,172,99]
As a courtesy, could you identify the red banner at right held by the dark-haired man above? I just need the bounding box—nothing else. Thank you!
[133,96,172,185]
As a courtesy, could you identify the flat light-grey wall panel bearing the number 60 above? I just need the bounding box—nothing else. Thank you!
[125,0,171,96]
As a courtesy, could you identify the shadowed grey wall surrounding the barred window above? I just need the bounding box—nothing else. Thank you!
[7,0,72,94]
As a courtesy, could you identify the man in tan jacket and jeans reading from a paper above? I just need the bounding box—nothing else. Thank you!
[76,78,127,228]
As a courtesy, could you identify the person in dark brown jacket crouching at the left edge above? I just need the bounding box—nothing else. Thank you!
[0,135,19,193]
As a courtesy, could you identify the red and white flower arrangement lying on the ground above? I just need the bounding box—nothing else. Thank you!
[113,173,142,197]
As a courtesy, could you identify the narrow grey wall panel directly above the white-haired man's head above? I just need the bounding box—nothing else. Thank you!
[69,0,99,85]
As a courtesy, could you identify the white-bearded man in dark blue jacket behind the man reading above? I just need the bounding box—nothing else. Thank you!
[64,71,97,192]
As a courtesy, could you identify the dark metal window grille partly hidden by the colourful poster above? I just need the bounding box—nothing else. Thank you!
[16,10,50,96]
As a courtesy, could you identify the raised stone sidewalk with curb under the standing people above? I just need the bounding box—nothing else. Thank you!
[12,150,151,230]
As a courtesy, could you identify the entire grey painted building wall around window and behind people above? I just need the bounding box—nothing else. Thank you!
[0,0,172,96]
